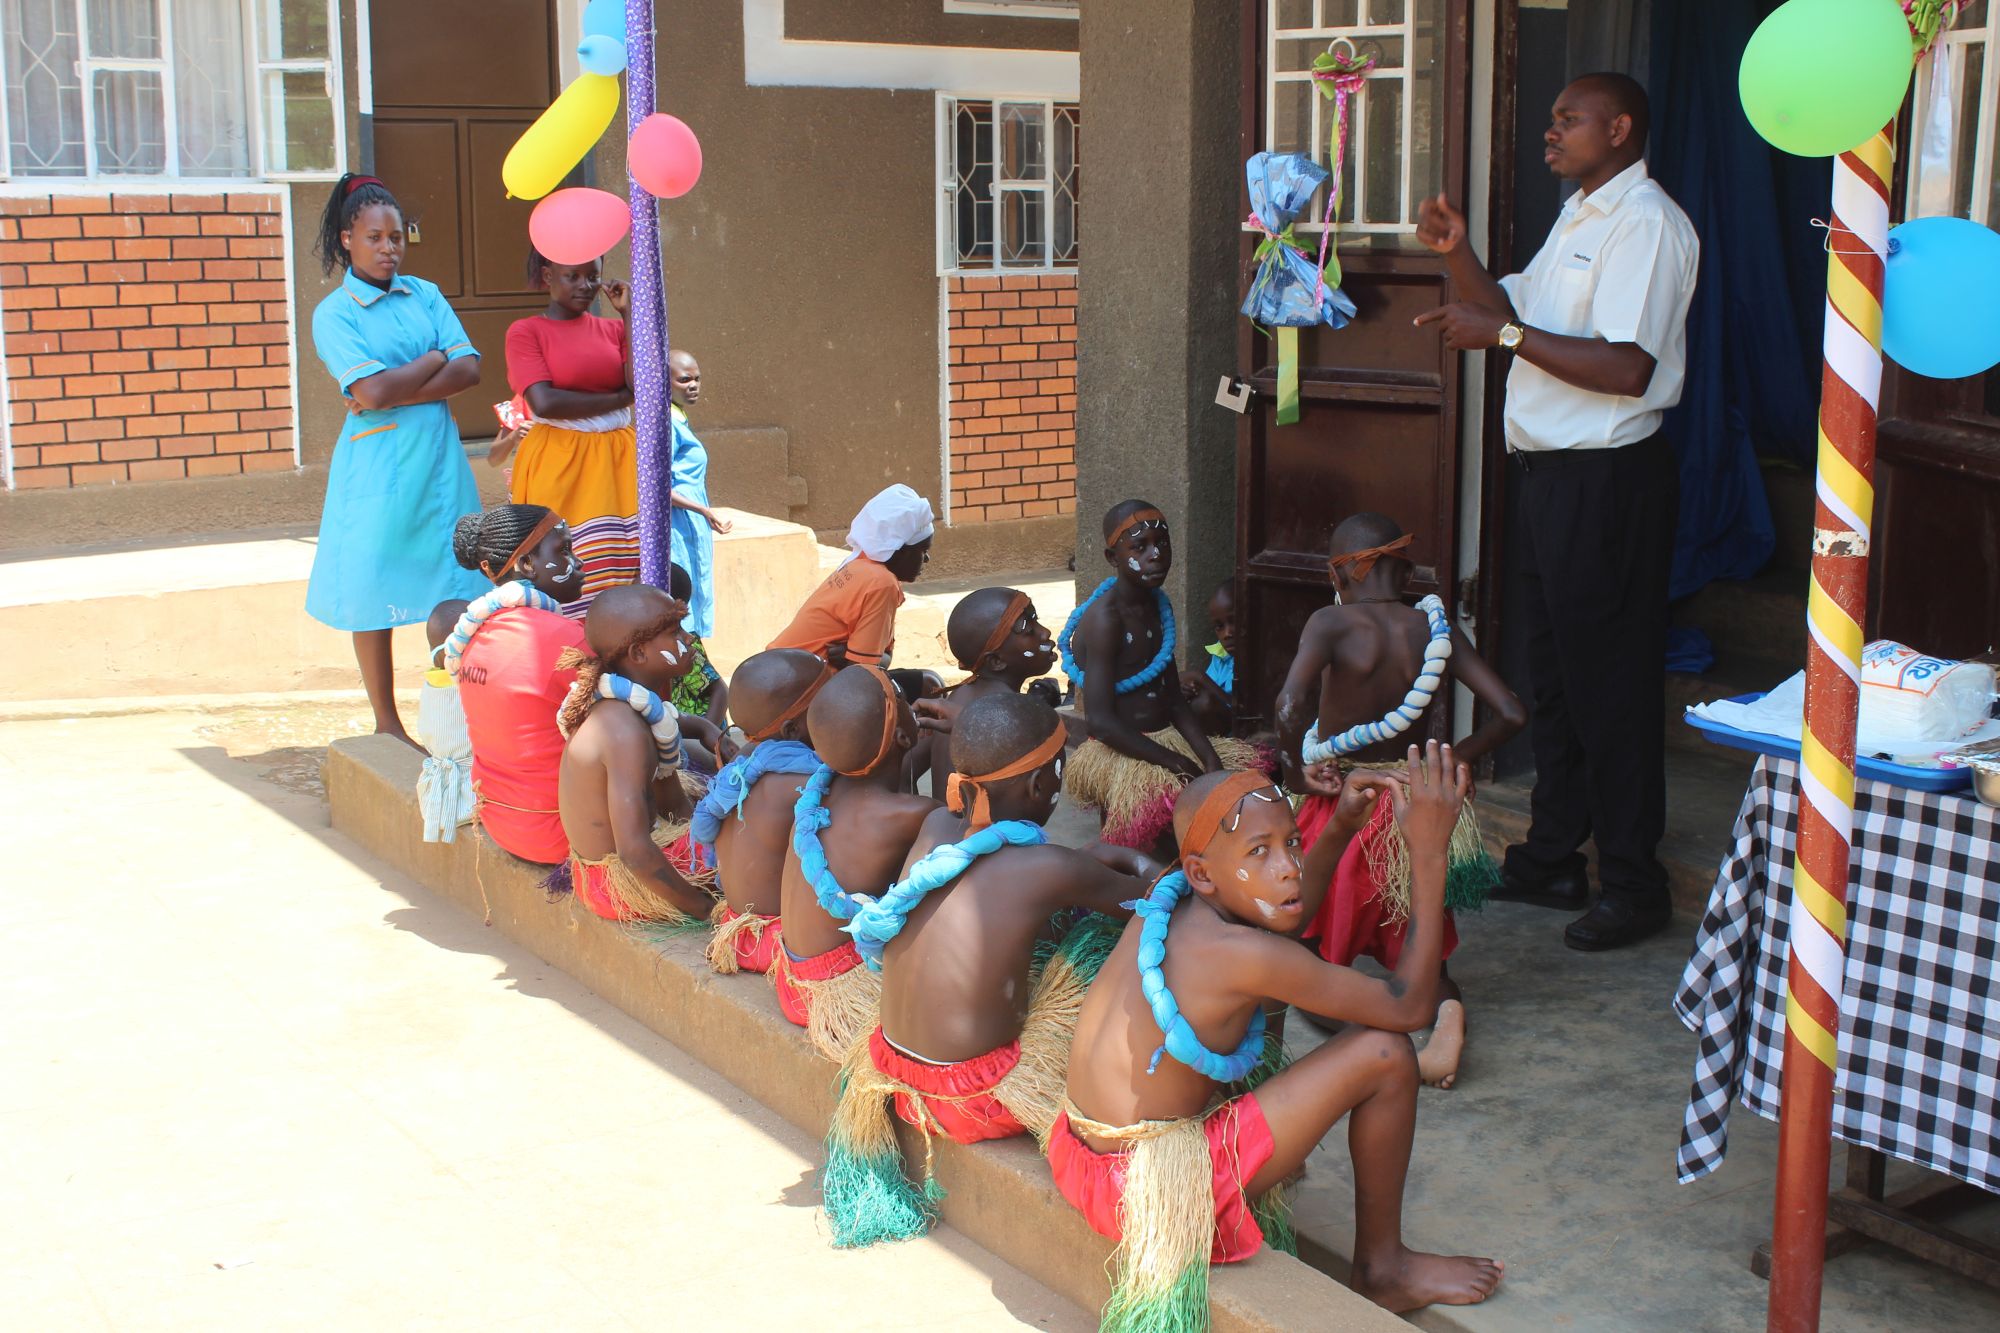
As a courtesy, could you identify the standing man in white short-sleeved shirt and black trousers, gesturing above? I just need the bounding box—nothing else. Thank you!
[1416,74,1700,951]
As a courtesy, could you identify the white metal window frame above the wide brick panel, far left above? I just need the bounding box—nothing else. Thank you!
[0,0,348,186]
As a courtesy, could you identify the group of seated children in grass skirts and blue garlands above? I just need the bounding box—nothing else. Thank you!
[426,488,1518,1329]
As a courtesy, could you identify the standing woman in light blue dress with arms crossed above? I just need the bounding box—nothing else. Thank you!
[306,174,486,741]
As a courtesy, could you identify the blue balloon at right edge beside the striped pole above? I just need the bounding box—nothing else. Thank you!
[1882,218,2000,380]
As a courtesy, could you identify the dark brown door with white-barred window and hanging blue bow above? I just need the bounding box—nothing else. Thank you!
[1236,0,1472,729]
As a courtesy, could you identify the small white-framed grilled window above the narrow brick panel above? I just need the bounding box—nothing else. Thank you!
[938,96,1082,272]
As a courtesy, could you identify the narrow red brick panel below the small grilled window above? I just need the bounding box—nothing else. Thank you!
[944,272,1076,524]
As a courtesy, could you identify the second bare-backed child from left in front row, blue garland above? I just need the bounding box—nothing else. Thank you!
[690,648,832,973]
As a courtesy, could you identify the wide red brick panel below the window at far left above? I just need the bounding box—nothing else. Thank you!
[0,194,294,488]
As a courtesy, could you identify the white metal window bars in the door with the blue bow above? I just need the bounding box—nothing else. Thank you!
[1264,0,1418,236]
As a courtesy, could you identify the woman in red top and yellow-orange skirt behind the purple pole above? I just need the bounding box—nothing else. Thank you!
[506,248,638,620]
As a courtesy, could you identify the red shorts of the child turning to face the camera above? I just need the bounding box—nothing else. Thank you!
[1048,1093,1278,1263]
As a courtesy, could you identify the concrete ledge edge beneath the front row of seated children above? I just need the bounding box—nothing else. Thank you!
[326,737,1408,1333]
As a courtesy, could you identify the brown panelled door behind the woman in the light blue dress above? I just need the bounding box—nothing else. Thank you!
[372,0,560,440]
